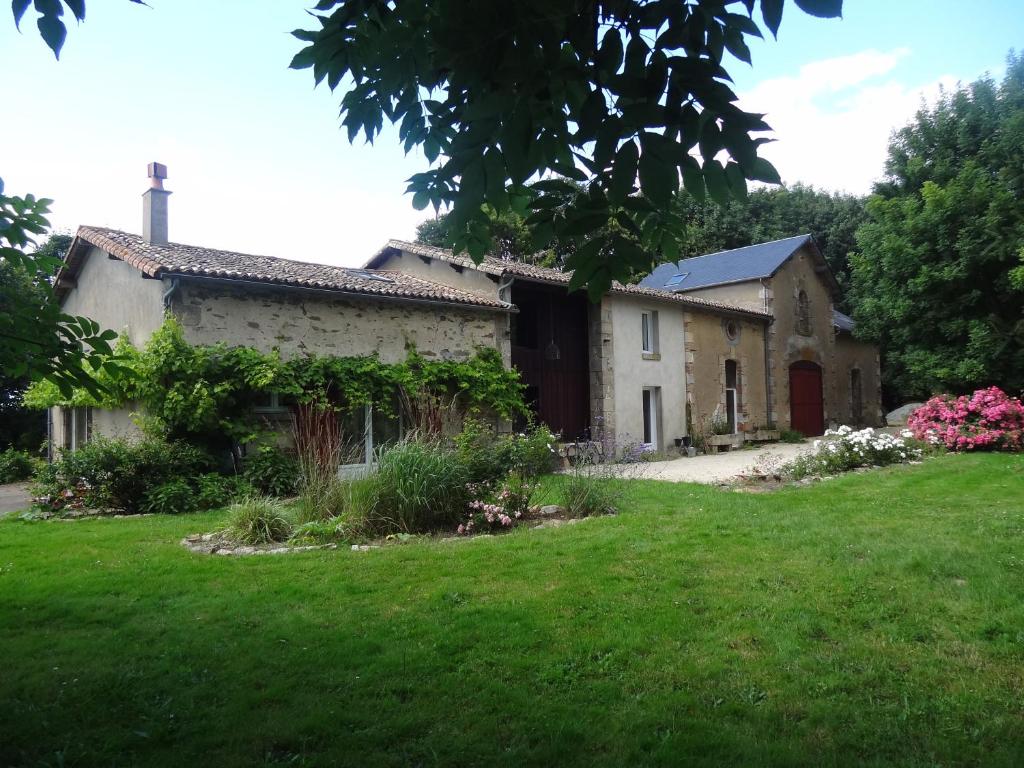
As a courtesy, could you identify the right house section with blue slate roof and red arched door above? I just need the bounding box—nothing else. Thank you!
[640,234,883,435]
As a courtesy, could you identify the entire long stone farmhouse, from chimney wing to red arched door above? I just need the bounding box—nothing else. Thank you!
[50,164,881,461]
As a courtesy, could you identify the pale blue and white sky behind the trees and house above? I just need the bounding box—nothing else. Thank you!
[0,0,1024,266]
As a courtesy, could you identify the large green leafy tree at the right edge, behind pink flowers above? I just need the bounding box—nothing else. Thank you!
[852,54,1024,398]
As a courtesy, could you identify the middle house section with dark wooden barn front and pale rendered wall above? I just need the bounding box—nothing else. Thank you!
[365,240,770,451]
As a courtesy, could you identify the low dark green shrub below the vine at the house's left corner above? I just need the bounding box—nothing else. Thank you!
[36,437,212,514]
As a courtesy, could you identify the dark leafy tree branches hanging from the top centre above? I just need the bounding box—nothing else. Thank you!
[292,0,842,294]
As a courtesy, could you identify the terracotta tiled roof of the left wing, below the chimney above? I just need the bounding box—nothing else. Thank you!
[57,226,513,309]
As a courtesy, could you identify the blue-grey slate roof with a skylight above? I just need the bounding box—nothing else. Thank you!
[640,234,814,292]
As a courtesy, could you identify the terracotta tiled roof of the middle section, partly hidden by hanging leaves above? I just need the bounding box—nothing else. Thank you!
[367,240,771,318]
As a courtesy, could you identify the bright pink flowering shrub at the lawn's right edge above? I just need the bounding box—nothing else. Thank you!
[906,387,1024,451]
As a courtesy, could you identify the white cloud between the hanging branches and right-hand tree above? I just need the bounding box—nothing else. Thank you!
[739,48,956,194]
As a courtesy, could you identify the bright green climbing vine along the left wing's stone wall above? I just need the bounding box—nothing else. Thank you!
[25,317,525,445]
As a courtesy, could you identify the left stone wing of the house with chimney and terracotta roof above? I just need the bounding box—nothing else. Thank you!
[49,164,514,456]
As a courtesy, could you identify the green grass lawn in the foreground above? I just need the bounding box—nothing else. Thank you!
[0,455,1024,766]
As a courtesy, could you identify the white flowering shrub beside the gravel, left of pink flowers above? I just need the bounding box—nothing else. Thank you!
[782,426,923,480]
